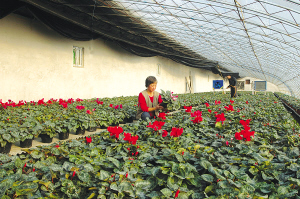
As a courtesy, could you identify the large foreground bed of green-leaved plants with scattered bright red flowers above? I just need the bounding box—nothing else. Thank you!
[0,93,300,199]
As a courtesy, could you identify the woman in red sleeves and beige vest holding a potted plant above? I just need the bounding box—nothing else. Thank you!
[136,76,163,120]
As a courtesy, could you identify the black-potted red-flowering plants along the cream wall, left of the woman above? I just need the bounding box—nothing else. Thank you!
[0,97,136,150]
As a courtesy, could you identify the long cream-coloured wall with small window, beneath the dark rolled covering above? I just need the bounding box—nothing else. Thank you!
[0,14,274,101]
